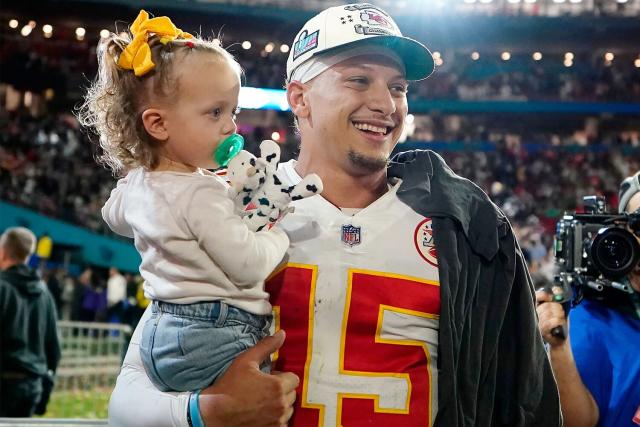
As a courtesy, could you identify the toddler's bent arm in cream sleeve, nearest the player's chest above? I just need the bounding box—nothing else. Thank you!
[185,184,289,286]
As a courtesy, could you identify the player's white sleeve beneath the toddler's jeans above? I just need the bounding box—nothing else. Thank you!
[109,307,190,427]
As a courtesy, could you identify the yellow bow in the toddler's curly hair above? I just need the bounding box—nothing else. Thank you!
[118,10,193,77]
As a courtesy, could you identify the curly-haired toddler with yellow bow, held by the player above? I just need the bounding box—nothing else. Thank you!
[79,11,289,391]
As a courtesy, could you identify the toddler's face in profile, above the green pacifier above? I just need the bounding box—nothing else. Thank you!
[161,52,240,169]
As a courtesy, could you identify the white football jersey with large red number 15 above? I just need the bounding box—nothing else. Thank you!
[266,162,440,427]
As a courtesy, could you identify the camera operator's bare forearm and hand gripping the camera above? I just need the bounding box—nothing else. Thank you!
[536,290,599,427]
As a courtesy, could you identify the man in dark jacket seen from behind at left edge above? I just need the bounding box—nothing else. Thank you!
[0,227,60,417]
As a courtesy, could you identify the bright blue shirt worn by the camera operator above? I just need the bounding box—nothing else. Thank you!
[569,299,640,427]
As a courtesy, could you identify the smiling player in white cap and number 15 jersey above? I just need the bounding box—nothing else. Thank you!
[110,4,560,427]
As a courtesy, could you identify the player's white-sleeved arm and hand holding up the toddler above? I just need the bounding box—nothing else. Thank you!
[109,307,298,427]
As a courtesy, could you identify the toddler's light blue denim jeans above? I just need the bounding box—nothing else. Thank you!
[140,301,272,391]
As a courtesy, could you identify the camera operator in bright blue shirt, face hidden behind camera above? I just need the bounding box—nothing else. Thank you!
[536,172,640,427]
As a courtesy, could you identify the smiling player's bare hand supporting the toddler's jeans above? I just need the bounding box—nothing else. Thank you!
[200,331,300,427]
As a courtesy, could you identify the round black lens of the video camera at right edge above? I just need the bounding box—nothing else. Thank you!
[589,227,640,279]
